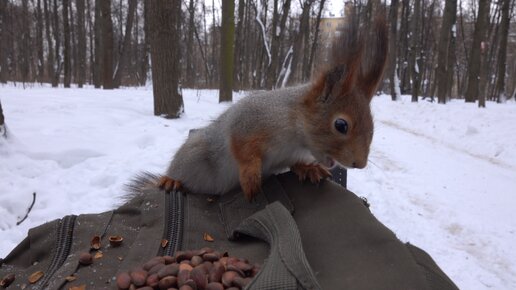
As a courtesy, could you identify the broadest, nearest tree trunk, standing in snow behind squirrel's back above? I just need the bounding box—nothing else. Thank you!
[148,0,184,118]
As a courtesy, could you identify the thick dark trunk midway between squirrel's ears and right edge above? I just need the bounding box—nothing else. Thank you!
[435,0,457,104]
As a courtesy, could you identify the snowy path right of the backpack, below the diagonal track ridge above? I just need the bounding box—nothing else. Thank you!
[349,116,516,289]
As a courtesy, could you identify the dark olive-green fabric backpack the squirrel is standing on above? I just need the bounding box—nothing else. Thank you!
[0,171,457,290]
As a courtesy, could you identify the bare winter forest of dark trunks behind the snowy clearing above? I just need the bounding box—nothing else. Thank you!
[0,0,516,111]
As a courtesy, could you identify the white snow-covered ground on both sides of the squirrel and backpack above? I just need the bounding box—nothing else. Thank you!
[0,85,516,289]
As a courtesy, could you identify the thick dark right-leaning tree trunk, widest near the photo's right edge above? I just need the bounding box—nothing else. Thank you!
[465,0,491,102]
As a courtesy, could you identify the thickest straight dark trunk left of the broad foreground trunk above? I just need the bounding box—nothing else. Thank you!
[100,0,114,90]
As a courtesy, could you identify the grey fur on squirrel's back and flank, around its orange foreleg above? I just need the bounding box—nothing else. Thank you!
[166,85,315,194]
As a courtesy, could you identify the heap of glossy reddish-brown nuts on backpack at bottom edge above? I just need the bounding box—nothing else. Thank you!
[116,248,260,290]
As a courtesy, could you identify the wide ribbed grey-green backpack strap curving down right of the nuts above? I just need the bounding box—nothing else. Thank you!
[233,202,321,290]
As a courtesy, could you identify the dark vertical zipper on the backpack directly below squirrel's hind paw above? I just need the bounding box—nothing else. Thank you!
[158,190,185,256]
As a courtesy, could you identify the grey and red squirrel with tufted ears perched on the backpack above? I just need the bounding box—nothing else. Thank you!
[158,18,388,201]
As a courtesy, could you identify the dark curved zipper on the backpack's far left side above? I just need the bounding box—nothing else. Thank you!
[37,215,77,289]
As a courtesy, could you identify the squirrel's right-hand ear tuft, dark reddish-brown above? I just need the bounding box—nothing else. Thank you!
[358,15,389,101]
